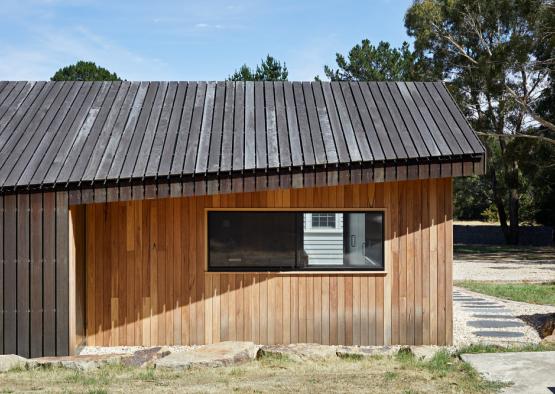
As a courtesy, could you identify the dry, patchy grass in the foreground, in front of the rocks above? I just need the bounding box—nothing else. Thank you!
[0,351,504,393]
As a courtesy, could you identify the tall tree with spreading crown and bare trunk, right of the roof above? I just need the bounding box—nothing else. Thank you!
[405,0,555,244]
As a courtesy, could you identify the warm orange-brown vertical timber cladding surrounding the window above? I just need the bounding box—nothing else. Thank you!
[84,179,452,346]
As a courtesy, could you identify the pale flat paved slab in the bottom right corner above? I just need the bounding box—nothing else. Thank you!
[461,352,555,394]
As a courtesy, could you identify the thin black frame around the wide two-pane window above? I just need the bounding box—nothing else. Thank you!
[205,209,387,273]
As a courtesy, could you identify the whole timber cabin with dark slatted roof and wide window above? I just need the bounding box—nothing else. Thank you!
[0,82,485,357]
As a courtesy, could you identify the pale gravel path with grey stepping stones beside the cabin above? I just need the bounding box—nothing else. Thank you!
[453,287,555,347]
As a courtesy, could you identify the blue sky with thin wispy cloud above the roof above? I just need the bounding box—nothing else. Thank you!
[0,0,411,80]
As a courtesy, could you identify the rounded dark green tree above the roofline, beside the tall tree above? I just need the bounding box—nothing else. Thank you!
[324,40,437,81]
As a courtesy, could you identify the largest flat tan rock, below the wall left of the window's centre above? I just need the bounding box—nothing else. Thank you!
[154,342,260,369]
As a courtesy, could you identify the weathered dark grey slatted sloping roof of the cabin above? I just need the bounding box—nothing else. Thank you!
[0,81,484,192]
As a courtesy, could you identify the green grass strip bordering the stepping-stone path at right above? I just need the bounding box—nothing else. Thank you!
[455,280,555,305]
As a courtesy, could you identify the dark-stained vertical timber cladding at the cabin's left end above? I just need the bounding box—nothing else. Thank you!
[0,192,69,357]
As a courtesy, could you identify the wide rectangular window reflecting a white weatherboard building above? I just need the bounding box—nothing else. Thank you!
[208,211,384,271]
